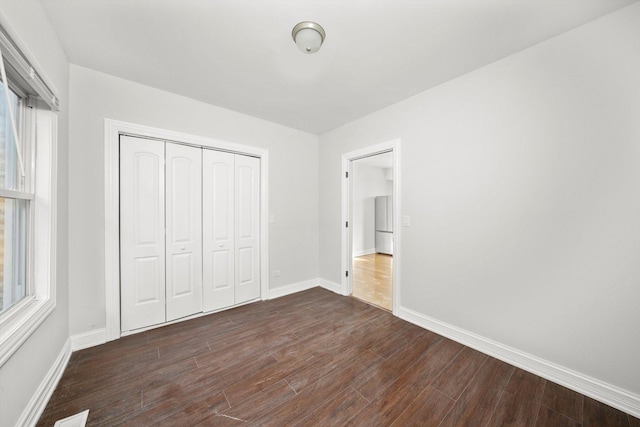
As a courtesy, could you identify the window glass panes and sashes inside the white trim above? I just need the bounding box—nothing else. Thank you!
[0,80,33,316]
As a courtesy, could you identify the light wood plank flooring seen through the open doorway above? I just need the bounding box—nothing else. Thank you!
[352,254,393,311]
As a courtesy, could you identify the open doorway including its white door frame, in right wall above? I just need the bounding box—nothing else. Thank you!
[341,140,401,314]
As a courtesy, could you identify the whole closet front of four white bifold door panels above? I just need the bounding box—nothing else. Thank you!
[120,135,260,331]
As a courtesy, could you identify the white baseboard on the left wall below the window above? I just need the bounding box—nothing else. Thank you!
[16,339,71,426]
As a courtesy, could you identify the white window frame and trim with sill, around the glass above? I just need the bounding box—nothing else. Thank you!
[0,23,58,367]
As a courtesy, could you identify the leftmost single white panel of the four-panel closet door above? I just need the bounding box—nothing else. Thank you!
[120,136,165,331]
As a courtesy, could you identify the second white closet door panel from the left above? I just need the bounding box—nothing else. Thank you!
[165,143,202,321]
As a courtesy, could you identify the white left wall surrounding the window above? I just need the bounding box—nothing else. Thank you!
[0,0,69,427]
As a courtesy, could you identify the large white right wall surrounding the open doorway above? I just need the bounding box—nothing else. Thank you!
[320,3,640,395]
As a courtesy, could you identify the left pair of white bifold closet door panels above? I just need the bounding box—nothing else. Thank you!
[120,136,202,331]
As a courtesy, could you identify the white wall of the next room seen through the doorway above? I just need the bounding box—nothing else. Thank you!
[352,160,391,256]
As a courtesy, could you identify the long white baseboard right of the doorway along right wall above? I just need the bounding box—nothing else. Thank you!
[398,307,640,417]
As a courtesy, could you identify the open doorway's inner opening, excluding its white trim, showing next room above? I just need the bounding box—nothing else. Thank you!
[351,151,393,311]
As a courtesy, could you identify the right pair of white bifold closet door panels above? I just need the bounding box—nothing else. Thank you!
[202,149,260,311]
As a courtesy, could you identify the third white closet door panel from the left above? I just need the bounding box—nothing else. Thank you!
[202,150,235,311]
